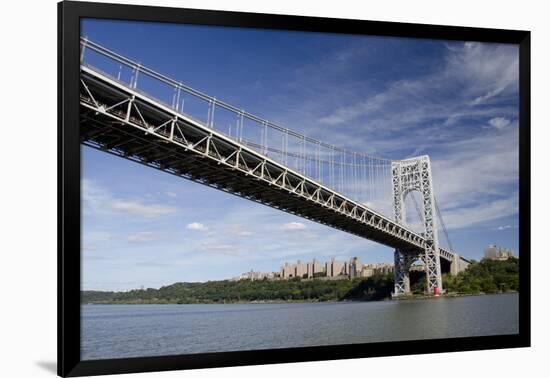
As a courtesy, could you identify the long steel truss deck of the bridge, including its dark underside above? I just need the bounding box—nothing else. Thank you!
[80,68,462,260]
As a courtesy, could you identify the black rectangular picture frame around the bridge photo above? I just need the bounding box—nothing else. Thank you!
[58,1,531,376]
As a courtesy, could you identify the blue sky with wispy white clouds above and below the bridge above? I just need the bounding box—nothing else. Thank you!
[81,20,519,290]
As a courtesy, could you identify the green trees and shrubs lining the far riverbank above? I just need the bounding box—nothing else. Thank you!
[81,258,519,304]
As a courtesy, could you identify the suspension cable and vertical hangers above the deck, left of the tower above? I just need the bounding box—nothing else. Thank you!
[80,38,392,217]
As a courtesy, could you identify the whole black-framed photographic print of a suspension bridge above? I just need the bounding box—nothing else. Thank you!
[58,2,530,376]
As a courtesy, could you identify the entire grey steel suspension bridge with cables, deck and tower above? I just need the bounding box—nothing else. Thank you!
[80,38,469,296]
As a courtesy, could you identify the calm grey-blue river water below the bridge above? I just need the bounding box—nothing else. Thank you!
[81,294,518,360]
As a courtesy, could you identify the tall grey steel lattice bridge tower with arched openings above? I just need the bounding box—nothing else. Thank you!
[391,155,442,296]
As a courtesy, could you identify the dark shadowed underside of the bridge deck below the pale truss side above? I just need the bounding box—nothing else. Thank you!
[80,71,467,268]
